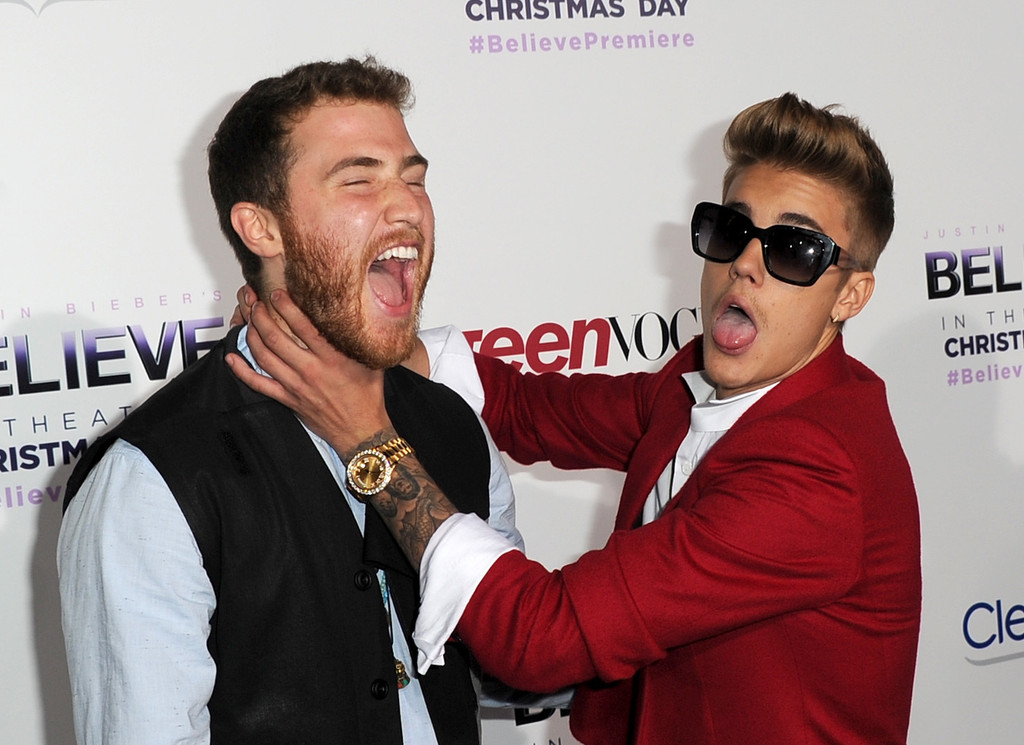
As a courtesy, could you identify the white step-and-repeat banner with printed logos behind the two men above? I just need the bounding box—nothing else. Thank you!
[0,0,1024,745]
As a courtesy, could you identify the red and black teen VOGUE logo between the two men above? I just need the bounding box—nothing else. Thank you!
[464,308,700,373]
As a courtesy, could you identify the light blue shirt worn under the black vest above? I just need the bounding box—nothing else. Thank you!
[57,330,522,745]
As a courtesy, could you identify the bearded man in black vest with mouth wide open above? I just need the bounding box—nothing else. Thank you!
[58,58,518,745]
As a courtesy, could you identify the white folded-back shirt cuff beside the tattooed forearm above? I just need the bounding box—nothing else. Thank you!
[413,514,517,675]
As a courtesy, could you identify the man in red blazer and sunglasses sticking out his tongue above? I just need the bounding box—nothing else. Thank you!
[235,94,921,745]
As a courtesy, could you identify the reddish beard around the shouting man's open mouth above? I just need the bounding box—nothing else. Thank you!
[281,213,430,369]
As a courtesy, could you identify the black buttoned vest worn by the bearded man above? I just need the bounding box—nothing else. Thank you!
[65,330,489,745]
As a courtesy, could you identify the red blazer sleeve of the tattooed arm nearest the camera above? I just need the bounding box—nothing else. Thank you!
[458,417,864,691]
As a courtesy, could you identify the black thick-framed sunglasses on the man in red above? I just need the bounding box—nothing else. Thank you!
[690,202,843,288]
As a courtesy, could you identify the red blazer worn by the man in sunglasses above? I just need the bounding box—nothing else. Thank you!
[458,339,921,745]
